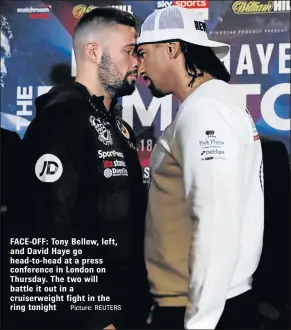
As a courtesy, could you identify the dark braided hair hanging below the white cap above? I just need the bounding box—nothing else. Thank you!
[180,41,230,87]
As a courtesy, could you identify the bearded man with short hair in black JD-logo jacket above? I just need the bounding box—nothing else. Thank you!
[6,8,151,329]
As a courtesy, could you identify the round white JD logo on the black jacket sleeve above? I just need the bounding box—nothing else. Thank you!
[35,154,63,182]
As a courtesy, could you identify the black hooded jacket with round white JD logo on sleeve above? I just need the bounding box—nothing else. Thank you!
[10,82,146,329]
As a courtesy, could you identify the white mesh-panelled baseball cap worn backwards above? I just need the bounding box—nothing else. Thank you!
[137,6,230,59]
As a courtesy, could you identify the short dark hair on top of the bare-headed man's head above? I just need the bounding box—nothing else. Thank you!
[74,7,136,34]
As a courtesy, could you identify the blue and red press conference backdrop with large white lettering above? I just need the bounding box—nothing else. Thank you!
[1,0,290,182]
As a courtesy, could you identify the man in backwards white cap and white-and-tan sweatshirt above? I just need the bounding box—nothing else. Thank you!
[137,6,264,329]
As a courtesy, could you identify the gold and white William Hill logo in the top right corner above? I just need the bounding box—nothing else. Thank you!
[232,1,290,15]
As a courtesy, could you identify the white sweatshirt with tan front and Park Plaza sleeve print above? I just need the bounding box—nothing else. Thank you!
[145,80,264,329]
